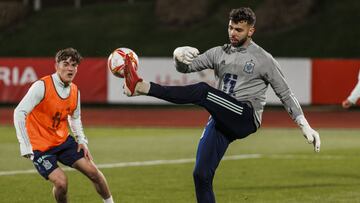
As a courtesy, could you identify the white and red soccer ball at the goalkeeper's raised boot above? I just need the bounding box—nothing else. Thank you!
[107,48,139,78]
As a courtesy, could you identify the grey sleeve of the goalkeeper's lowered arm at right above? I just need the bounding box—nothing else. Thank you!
[265,57,304,121]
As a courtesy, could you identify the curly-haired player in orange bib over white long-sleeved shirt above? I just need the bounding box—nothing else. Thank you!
[14,48,113,203]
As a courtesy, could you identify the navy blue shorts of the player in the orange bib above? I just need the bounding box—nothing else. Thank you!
[33,135,84,180]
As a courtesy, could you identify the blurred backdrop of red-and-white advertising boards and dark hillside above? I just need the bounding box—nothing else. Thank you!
[0,0,360,111]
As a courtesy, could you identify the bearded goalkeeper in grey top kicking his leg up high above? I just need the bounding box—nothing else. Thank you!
[124,8,320,203]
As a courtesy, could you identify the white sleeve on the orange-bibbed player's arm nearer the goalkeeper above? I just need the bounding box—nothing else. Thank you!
[68,91,88,144]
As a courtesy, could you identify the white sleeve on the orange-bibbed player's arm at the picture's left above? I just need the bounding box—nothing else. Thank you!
[14,80,45,156]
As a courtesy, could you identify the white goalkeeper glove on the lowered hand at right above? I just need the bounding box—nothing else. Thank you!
[296,115,321,152]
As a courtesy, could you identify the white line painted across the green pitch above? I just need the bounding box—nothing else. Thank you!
[0,154,344,176]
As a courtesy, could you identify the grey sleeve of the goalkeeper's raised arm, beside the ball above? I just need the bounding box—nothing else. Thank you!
[174,47,221,73]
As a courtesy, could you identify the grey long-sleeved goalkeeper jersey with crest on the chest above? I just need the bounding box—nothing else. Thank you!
[175,41,303,127]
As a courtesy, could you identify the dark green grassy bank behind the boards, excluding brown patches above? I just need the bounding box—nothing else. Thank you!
[0,0,360,58]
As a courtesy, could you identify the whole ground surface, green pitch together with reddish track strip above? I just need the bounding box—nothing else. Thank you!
[0,106,360,203]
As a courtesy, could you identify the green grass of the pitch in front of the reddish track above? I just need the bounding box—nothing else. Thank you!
[0,126,360,203]
